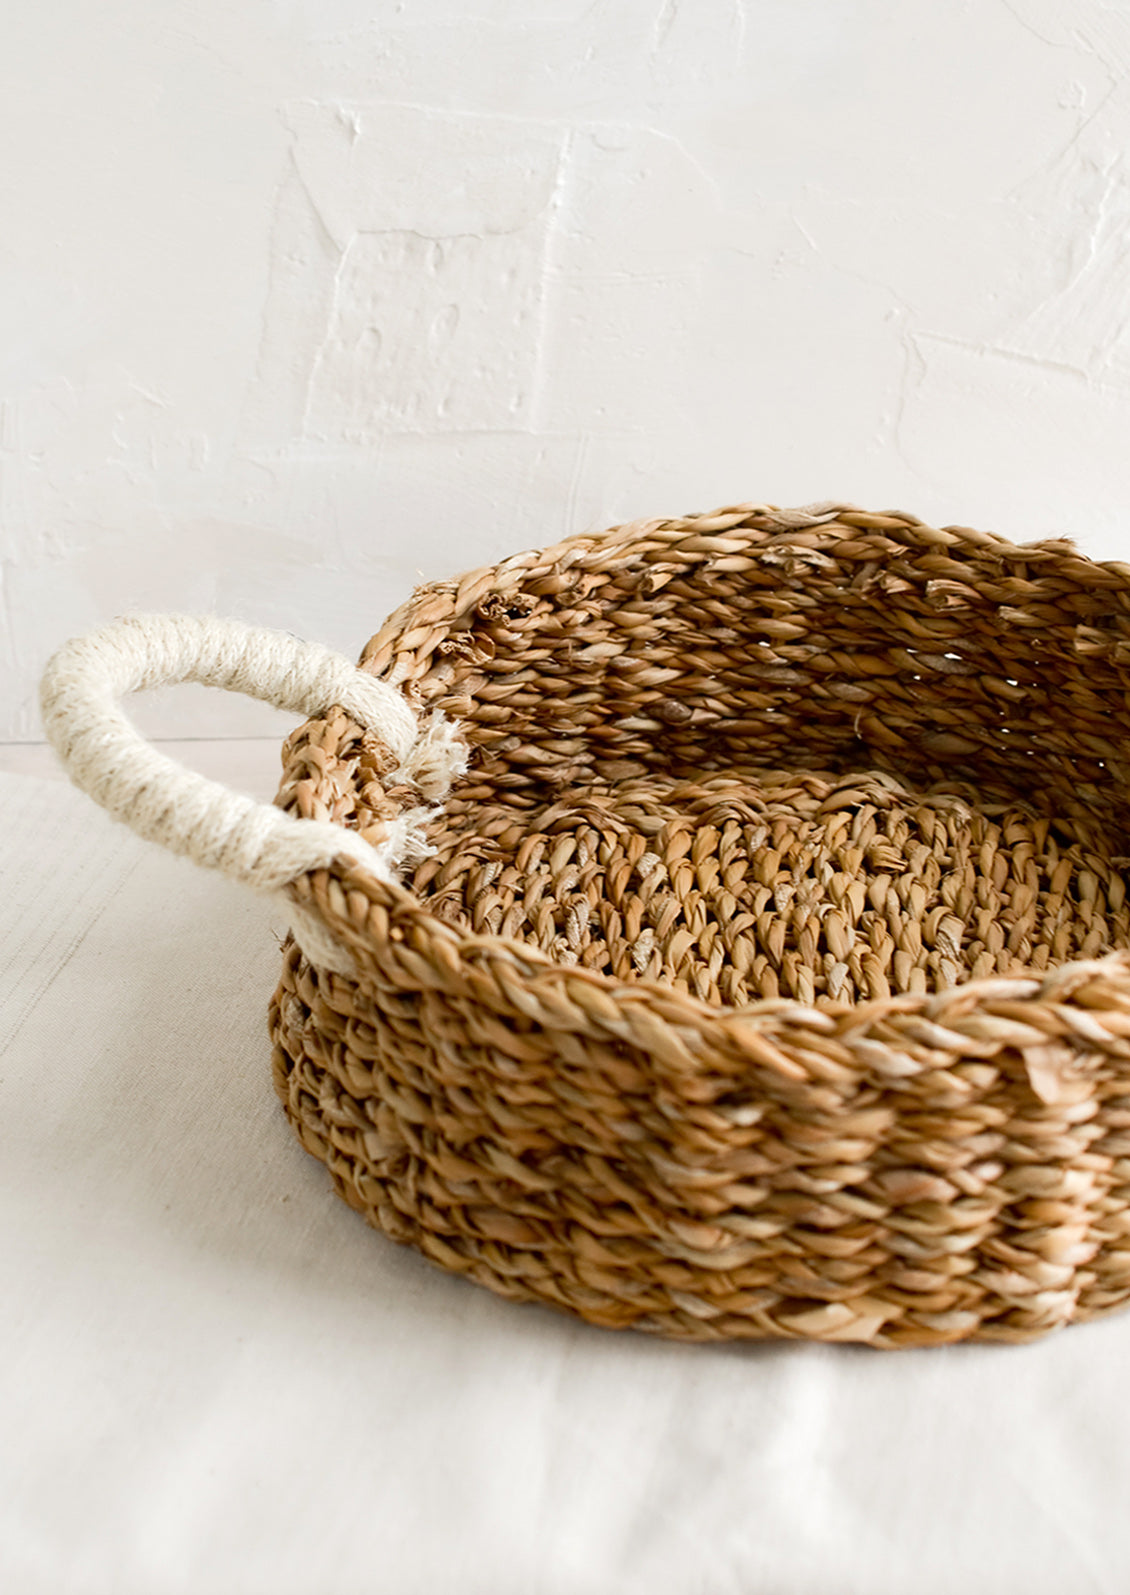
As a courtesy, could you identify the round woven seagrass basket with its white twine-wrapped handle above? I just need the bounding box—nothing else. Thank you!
[43,504,1130,1346]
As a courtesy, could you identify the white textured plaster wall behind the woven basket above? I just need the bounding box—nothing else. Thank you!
[0,0,1130,738]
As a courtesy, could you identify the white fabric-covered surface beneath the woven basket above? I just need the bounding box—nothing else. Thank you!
[0,775,1130,1595]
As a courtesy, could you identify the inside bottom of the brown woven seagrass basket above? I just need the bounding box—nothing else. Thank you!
[405,770,1130,1008]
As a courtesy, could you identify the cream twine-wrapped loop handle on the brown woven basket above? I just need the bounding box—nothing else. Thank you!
[40,614,466,970]
